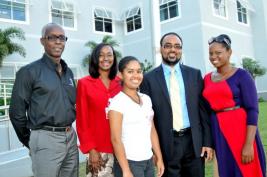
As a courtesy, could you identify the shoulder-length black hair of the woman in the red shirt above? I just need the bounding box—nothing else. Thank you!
[89,43,118,79]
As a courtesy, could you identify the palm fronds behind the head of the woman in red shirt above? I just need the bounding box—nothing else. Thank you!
[83,35,121,66]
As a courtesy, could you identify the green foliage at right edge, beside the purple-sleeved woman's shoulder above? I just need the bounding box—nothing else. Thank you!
[242,57,266,79]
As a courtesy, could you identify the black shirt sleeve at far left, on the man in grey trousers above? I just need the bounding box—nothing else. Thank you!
[9,67,33,148]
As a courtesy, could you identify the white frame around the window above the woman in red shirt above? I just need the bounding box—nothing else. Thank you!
[92,7,115,36]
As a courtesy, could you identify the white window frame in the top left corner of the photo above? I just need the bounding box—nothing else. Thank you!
[0,0,30,24]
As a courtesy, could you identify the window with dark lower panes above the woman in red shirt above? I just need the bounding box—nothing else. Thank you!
[94,8,113,33]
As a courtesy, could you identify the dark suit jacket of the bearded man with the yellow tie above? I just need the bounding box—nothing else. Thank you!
[140,65,212,162]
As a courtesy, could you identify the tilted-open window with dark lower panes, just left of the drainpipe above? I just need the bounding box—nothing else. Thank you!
[125,7,142,33]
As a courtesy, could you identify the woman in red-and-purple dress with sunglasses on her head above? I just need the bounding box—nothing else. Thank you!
[203,34,266,177]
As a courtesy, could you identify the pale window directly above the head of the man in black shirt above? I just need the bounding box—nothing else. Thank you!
[51,0,75,28]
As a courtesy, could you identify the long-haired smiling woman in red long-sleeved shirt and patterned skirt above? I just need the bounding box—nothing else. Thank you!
[76,43,121,177]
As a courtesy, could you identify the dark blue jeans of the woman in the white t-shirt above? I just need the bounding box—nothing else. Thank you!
[113,158,155,177]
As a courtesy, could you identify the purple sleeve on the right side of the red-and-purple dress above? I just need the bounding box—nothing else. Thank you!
[239,70,259,125]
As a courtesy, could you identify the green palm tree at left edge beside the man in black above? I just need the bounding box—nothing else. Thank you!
[0,27,26,67]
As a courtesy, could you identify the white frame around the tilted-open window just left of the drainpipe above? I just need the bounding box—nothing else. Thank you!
[123,6,144,35]
